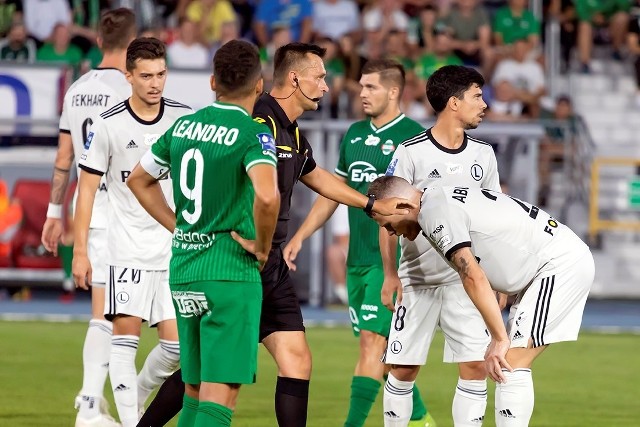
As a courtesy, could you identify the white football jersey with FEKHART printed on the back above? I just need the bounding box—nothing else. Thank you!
[60,68,131,228]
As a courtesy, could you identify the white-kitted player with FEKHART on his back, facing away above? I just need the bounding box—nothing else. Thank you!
[42,8,136,427]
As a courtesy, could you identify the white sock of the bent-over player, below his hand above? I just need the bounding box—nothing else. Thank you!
[496,368,534,427]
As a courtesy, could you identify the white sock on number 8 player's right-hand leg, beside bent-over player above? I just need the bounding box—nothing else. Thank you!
[451,378,487,427]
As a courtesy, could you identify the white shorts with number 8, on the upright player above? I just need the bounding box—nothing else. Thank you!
[383,284,490,366]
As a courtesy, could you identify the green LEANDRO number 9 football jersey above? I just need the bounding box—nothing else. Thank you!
[151,102,277,284]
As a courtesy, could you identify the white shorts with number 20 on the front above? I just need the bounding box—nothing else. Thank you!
[104,265,176,326]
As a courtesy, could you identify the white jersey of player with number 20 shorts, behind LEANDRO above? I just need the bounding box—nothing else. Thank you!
[80,98,193,270]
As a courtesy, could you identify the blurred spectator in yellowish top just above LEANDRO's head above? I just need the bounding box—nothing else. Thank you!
[186,0,237,45]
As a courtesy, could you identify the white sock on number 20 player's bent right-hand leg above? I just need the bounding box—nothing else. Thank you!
[138,340,180,408]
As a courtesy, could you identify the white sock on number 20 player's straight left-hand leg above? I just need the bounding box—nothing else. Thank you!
[109,335,140,427]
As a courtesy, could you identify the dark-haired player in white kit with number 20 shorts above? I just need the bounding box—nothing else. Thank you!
[73,38,192,427]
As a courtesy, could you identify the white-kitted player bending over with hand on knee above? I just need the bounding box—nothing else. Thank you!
[369,177,595,427]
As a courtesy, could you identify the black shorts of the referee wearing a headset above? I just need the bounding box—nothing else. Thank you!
[260,246,304,342]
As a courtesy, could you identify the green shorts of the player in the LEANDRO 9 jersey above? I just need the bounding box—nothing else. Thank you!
[171,281,262,384]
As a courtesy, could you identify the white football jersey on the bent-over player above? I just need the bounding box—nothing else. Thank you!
[418,186,587,294]
